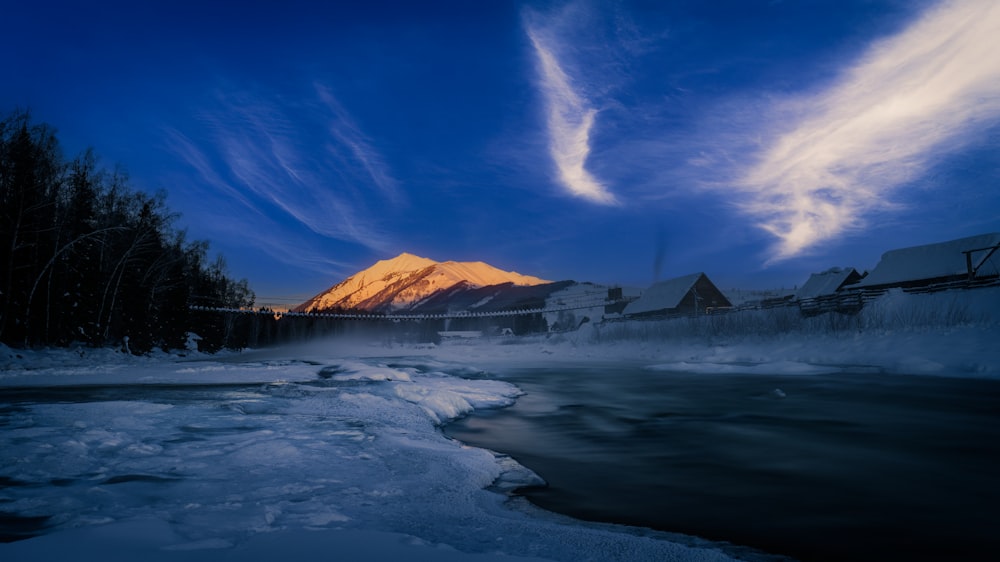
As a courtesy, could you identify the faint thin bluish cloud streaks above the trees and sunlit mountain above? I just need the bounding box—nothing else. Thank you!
[164,86,403,271]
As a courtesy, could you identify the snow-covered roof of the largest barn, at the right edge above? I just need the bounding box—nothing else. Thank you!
[856,232,1000,287]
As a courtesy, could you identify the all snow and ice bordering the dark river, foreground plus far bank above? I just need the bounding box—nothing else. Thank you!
[0,310,1000,560]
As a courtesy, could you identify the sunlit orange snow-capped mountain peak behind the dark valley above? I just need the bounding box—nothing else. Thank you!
[295,253,549,312]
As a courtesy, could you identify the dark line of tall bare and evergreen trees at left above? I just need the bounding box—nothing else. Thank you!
[0,111,255,353]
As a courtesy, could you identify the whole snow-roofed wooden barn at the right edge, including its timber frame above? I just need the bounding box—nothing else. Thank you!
[852,233,1000,289]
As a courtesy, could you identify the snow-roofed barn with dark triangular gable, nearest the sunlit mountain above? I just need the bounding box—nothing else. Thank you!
[622,273,733,318]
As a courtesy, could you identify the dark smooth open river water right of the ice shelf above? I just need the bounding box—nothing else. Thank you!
[446,367,1000,561]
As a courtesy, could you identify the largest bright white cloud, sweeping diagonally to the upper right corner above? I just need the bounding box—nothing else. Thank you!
[739,0,1000,261]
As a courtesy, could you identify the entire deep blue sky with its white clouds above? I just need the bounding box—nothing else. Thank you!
[0,0,1000,304]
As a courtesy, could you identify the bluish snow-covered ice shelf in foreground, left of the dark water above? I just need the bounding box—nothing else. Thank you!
[0,353,729,561]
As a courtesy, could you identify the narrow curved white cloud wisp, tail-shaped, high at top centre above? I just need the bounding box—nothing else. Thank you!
[525,8,618,205]
